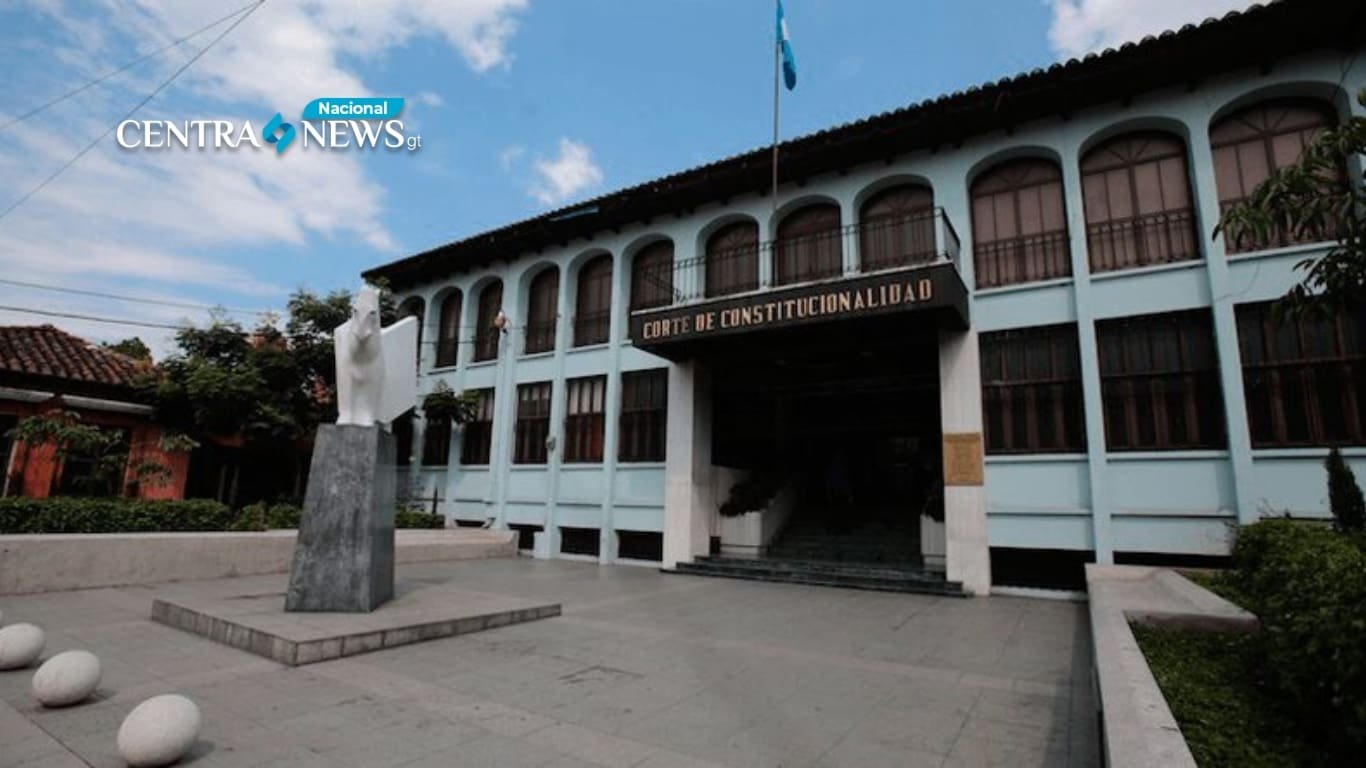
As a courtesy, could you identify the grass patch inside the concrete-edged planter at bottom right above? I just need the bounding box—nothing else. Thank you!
[1132,625,1324,768]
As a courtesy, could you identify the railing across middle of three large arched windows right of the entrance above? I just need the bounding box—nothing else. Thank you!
[1086,209,1201,272]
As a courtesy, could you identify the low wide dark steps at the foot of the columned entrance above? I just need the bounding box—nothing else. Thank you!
[675,558,966,597]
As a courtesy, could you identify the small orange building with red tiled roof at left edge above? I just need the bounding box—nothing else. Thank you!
[0,325,190,499]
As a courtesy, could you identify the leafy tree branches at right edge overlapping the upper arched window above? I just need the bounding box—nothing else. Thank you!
[1214,89,1366,314]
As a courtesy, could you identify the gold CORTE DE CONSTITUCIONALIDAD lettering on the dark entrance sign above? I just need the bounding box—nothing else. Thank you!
[641,271,934,340]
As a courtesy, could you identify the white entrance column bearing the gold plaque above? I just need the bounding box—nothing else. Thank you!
[940,329,992,594]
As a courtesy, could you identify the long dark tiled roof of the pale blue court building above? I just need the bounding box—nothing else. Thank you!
[363,0,1366,288]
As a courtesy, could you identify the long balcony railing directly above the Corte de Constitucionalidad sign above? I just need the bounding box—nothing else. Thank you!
[641,208,960,306]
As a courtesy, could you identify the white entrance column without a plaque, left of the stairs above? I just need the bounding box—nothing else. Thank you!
[663,361,714,568]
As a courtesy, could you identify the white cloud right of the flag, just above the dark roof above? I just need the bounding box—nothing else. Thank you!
[1048,0,1254,59]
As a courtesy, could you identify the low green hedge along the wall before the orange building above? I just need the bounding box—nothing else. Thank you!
[0,496,235,533]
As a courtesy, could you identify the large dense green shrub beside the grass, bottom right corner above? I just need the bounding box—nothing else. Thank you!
[1231,519,1366,757]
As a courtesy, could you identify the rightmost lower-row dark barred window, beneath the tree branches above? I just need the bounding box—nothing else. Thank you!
[1236,302,1366,448]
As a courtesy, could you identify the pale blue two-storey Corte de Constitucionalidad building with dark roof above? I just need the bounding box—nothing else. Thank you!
[367,0,1366,593]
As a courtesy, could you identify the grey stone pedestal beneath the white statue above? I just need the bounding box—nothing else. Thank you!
[284,424,395,612]
